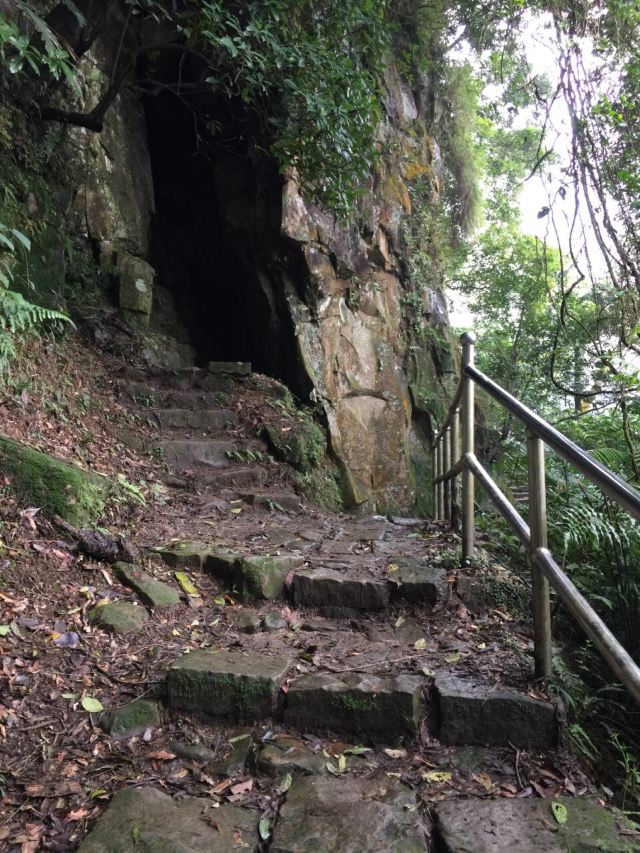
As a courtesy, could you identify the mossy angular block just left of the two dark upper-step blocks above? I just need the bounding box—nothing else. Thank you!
[204,550,304,600]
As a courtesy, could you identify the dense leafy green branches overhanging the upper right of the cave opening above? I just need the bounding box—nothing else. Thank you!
[180,0,389,215]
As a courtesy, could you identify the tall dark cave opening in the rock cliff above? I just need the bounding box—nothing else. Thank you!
[144,75,308,394]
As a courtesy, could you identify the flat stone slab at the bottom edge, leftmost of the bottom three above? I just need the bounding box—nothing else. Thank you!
[79,787,259,853]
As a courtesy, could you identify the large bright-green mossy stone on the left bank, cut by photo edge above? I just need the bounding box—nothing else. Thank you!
[0,436,111,527]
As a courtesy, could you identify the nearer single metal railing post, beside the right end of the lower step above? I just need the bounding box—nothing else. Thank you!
[527,429,553,678]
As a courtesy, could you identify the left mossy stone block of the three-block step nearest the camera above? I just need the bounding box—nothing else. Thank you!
[167,650,291,720]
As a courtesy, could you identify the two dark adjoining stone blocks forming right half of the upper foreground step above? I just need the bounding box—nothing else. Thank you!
[293,558,447,610]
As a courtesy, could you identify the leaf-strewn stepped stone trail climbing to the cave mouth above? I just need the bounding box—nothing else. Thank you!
[0,356,638,853]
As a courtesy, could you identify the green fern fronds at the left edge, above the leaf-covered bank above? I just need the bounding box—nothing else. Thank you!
[0,223,73,374]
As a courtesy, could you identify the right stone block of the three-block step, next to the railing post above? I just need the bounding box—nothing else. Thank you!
[434,673,558,749]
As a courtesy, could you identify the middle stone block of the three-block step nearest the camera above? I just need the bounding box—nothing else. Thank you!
[285,672,424,742]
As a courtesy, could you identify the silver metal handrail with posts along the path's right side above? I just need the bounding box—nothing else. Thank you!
[432,333,640,704]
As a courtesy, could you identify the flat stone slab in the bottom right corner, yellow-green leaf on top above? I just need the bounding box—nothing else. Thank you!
[434,797,640,853]
